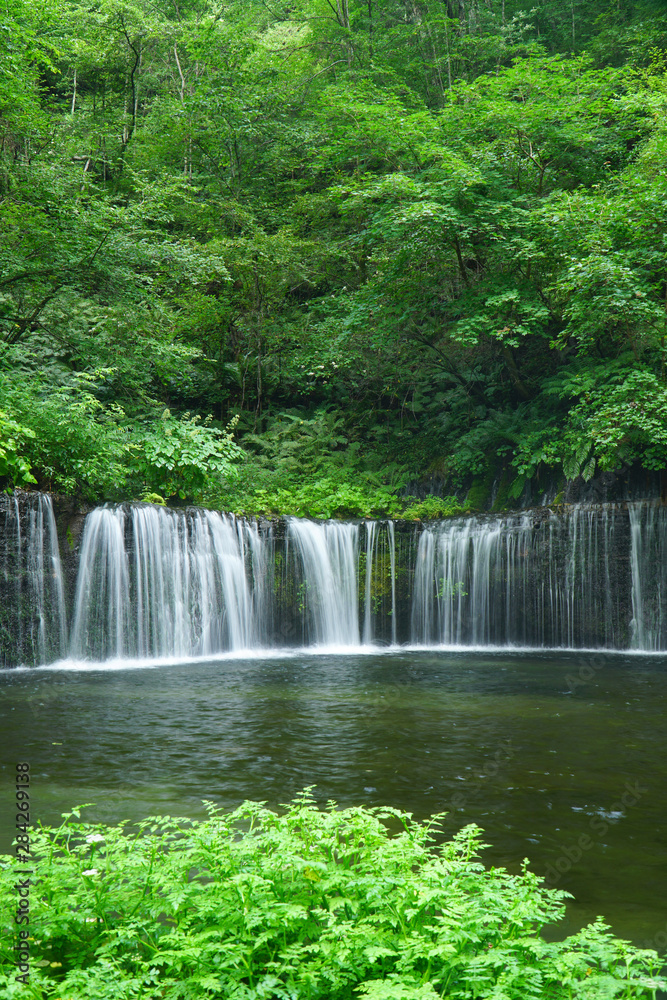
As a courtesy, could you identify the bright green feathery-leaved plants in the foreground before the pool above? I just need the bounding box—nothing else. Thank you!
[0,793,667,1000]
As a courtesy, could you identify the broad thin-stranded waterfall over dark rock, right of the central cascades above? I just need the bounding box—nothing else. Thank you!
[412,504,636,648]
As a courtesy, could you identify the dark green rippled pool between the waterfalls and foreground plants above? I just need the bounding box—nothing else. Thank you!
[0,650,667,949]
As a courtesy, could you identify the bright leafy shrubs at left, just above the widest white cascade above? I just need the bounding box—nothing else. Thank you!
[0,370,242,503]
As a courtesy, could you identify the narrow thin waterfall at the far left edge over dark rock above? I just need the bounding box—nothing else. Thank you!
[0,493,66,665]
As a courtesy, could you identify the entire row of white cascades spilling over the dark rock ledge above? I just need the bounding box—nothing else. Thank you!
[0,494,667,664]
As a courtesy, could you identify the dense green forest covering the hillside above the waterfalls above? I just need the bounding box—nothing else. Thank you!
[0,0,667,516]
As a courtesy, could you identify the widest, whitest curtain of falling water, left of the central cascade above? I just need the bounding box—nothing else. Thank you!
[70,504,265,659]
